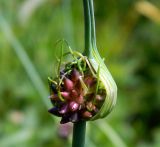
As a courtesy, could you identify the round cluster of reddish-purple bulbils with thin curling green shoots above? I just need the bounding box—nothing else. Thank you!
[49,53,106,124]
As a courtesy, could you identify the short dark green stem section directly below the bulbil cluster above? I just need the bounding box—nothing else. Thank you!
[72,121,86,147]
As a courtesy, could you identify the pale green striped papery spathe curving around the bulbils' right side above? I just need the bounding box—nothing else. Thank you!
[88,53,117,120]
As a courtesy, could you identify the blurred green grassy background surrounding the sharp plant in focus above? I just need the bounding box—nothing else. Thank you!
[0,0,160,147]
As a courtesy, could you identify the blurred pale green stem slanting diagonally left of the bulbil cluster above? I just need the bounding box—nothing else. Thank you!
[0,14,51,107]
